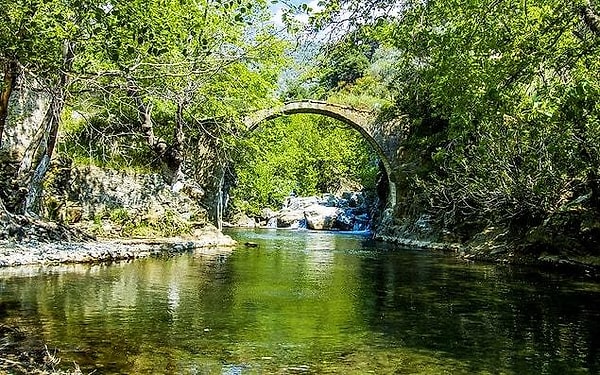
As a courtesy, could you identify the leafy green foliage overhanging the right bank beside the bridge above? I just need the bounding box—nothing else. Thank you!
[314,0,600,241]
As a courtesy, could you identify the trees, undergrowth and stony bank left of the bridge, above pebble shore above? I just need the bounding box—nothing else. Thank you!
[0,1,286,247]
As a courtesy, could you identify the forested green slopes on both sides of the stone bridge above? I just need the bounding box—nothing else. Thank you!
[0,0,600,268]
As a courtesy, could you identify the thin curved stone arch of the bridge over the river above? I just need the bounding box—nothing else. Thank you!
[244,100,396,207]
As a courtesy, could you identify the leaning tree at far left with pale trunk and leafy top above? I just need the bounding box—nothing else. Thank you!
[0,1,95,212]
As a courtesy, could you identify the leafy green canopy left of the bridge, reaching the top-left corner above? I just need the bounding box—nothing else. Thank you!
[0,0,287,176]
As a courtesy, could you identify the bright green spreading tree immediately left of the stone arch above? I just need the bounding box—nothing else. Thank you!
[71,0,284,183]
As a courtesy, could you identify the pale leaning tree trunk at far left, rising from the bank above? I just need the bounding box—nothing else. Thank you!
[18,41,75,214]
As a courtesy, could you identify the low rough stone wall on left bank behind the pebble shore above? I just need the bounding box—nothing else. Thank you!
[44,162,207,234]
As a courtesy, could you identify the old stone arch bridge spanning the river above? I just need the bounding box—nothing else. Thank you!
[244,100,398,207]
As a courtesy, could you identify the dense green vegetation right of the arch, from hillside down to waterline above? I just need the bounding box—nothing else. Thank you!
[293,0,600,270]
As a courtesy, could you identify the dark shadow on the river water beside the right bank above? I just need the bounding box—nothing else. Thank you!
[354,248,600,374]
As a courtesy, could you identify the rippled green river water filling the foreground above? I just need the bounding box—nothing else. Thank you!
[0,230,600,374]
